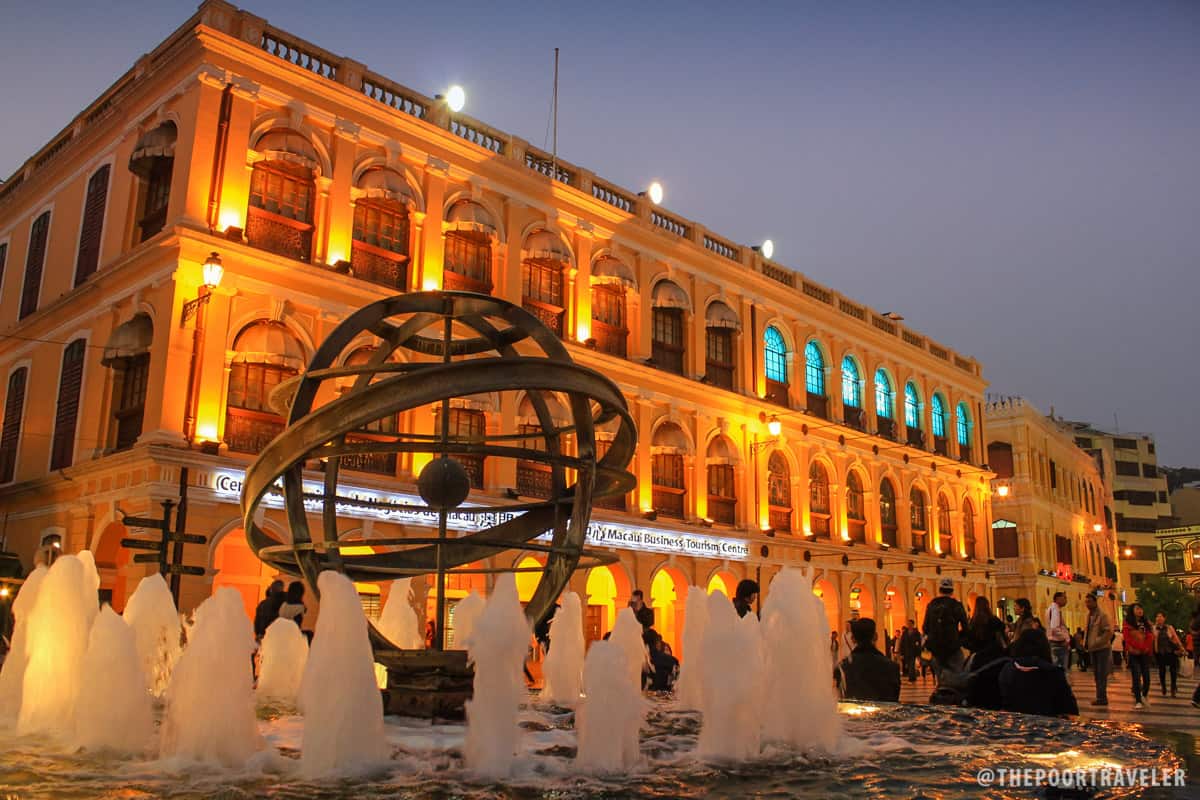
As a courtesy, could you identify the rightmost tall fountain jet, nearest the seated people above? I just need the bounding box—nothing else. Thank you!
[762,567,841,753]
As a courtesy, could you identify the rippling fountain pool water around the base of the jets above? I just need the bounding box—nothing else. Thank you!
[0,696,1193,800]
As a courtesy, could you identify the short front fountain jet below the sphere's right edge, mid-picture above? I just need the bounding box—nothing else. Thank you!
[573,633,649,775]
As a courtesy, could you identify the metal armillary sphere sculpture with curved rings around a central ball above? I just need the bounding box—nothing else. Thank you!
[241,291,636,649]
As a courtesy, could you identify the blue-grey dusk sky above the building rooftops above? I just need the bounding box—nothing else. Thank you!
[7,0,1200,465]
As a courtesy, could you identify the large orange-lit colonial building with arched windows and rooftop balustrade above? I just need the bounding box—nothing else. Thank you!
[0,0,993,651]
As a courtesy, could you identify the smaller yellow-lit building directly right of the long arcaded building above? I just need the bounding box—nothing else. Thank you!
[984,397,1126,630]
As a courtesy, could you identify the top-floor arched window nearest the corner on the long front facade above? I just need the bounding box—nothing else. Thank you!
[246,128,318,261]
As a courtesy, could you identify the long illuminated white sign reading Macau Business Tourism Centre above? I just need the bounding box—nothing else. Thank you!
[209,470,750,560]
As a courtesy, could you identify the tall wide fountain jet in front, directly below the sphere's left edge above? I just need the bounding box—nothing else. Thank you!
[297,570,390,777]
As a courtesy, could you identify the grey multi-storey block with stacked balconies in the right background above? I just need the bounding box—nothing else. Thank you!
[1058,420,1176,589]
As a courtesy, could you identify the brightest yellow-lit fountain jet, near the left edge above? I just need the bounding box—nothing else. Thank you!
[17,555,97,734]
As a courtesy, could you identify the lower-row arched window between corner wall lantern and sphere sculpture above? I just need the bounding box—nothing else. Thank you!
[224,320,305,453]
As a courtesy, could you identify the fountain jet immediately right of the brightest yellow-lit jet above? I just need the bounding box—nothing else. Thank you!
[73,604,154,753]
